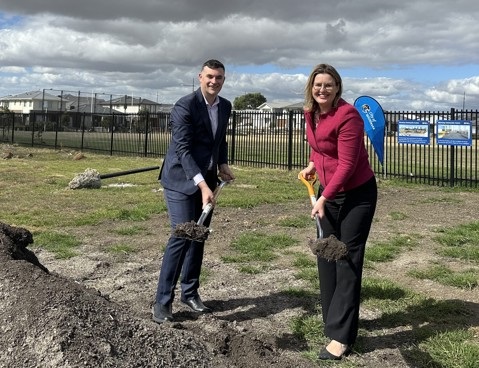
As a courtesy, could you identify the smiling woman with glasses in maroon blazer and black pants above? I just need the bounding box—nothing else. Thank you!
[301,64,377,360]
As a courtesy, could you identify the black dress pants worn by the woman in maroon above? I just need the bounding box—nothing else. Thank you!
[318,177,377,345]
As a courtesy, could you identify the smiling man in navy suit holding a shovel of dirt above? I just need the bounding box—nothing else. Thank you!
[152,60,234,323]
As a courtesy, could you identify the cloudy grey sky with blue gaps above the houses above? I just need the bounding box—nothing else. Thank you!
[0,0,479,111]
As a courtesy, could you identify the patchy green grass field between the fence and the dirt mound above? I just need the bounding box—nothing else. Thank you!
[0,145,479,368]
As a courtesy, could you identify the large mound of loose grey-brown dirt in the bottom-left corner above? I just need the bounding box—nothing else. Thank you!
[0,222,311,368]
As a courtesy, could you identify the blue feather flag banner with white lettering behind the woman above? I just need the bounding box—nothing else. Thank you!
[354,96,386,166]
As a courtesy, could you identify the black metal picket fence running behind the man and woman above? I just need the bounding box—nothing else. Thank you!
[0,109,479,188]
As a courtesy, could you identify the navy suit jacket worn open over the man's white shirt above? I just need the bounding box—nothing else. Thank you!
[159,88,231,195]
